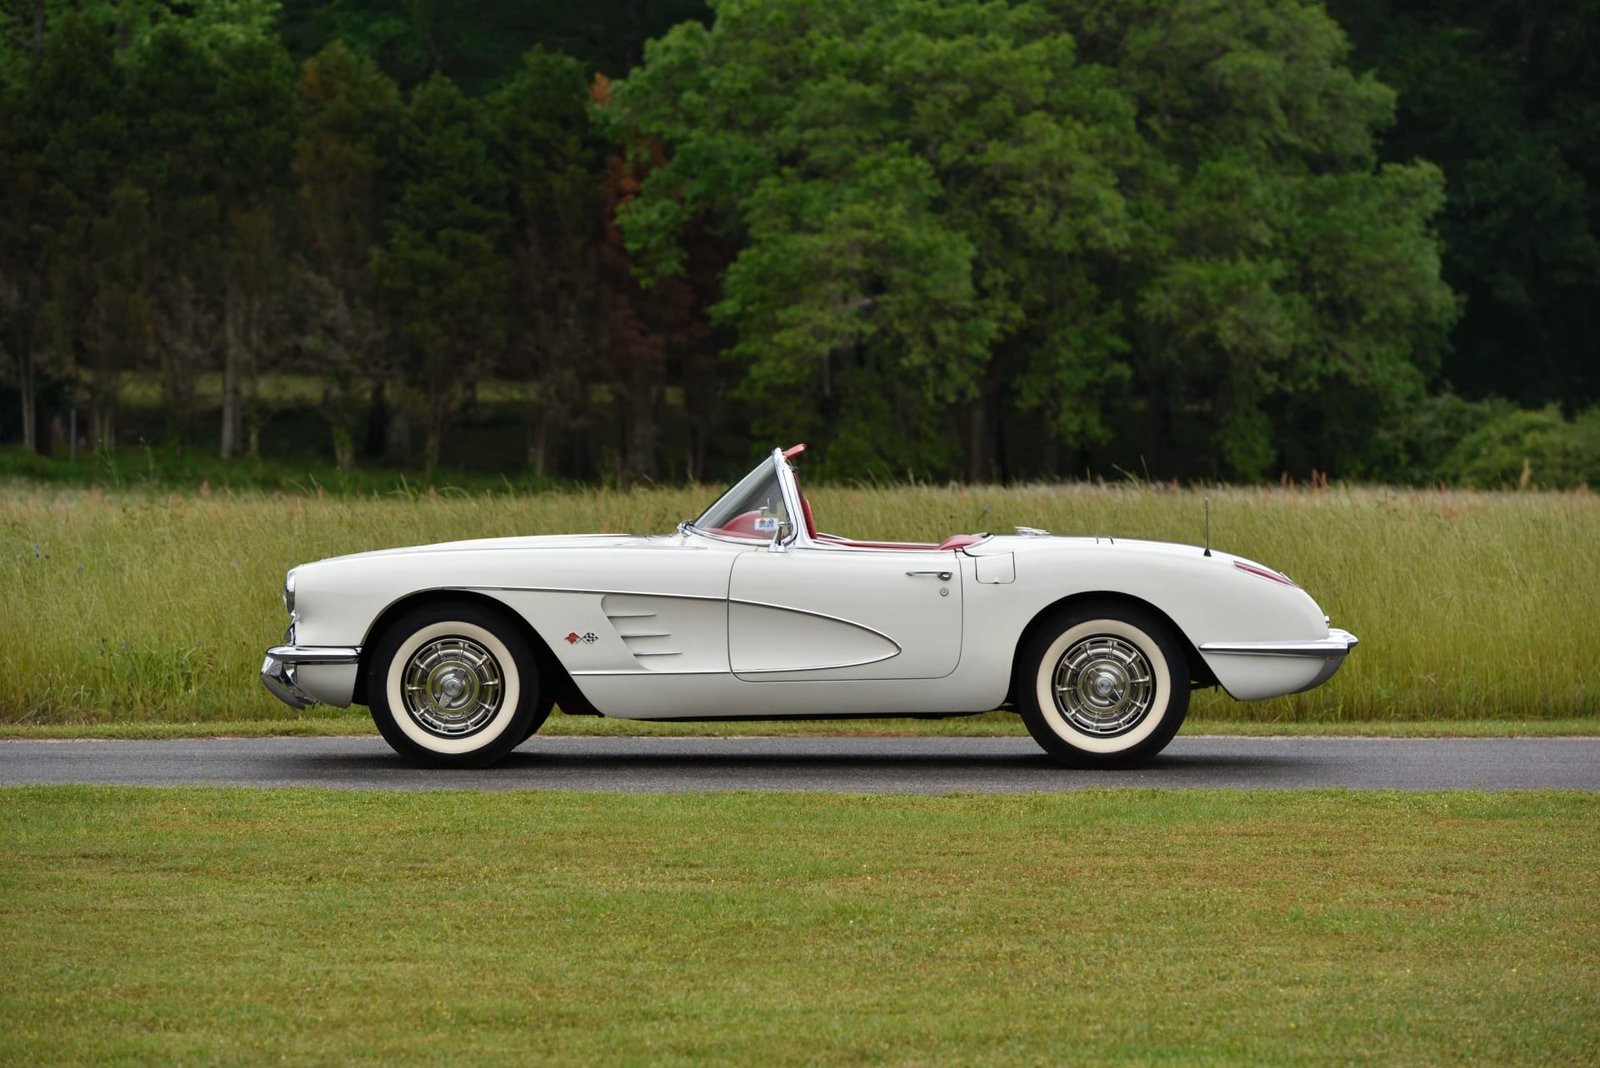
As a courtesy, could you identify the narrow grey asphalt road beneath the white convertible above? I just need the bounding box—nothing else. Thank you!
[0,735,1600,793]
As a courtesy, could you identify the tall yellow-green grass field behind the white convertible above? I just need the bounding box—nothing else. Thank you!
[0,483,1600,724]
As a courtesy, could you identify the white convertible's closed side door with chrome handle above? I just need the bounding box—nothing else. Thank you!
[728,547,962,683]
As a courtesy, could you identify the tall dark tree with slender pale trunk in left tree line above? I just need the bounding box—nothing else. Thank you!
[128,11,294,457]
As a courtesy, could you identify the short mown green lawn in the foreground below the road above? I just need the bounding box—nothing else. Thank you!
[0,788,1600,1065]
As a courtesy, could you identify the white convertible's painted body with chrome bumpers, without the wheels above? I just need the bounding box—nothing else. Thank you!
[262,452,1355,719]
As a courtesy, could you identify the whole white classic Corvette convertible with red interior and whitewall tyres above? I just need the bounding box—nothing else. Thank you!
[261,446,1355,767]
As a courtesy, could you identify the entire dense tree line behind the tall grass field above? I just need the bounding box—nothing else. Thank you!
[0,0,1600,483]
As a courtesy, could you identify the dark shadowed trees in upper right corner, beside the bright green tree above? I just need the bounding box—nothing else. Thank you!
[1328,0,1600,411]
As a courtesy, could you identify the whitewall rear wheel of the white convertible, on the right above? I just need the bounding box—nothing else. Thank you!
[1014,603,1189,767]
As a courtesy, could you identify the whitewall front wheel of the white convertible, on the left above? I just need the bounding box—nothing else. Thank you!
[366,603,549,767]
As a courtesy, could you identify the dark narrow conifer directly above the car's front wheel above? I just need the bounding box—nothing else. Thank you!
[373,75,507,472]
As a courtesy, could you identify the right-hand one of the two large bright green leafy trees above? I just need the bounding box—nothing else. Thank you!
[1069,3,1454,476]
